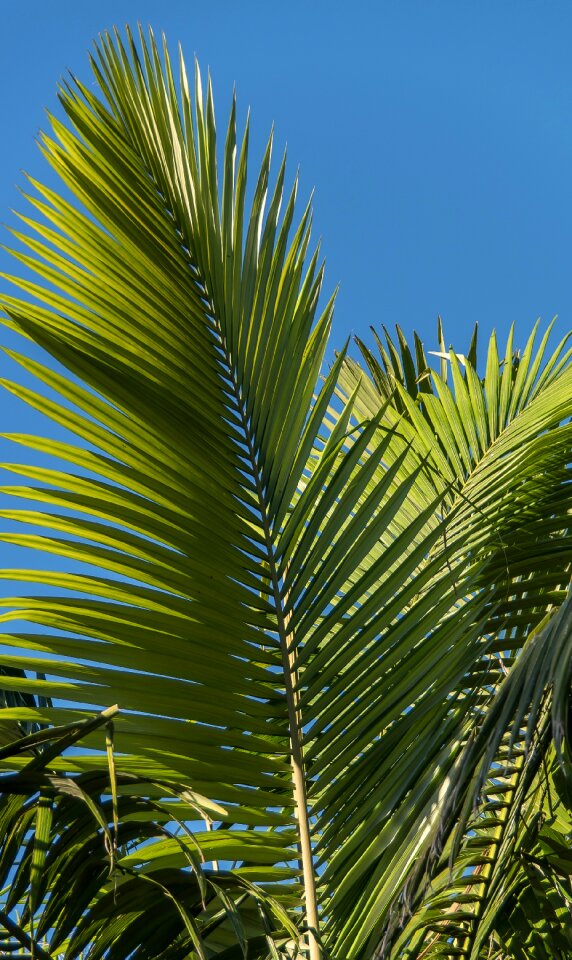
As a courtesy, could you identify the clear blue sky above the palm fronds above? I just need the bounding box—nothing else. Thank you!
[0,0,572,360]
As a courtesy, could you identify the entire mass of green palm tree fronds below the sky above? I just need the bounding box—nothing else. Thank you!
[0,26,572,960]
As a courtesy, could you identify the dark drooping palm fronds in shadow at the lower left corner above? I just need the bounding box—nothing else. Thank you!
[0,707,296,960]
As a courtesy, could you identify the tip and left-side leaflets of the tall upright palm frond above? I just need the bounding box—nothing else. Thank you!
[3,26,333,956]
